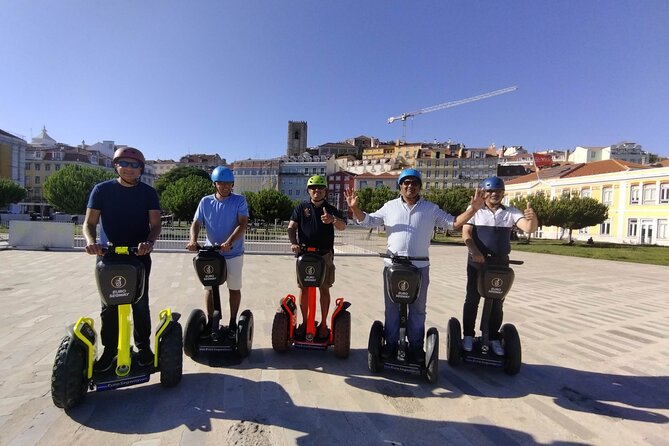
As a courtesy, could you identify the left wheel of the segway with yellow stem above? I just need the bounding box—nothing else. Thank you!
[51,335,88,409]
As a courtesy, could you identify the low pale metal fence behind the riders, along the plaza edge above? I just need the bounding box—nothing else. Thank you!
[0,220,386,256]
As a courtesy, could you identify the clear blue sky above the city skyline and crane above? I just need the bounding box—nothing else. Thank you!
[0,0,669,162]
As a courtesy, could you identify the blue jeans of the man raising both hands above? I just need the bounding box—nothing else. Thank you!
[383,266,430,348]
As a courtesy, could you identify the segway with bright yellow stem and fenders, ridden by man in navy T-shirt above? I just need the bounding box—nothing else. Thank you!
[51,247,183,409]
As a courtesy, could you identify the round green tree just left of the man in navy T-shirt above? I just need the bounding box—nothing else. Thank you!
[44,164,116,214]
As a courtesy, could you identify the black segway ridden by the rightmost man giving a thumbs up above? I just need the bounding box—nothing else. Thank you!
[446,259,524,375]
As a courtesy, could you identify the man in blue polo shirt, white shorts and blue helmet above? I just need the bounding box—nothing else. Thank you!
[186,166,249,338]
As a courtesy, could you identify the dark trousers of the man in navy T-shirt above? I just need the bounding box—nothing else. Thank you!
[100,255,151,351]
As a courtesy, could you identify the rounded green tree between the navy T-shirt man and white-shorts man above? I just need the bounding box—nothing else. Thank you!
[160,175,213,221]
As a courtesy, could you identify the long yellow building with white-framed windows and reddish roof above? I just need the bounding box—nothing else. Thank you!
[505,160,669,246]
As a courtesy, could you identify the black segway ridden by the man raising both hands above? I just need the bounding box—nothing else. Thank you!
[367,253,439,383]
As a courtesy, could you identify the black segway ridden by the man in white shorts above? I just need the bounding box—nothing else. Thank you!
[184,245,253,358]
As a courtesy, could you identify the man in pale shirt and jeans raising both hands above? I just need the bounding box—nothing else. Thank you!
[344,169,484,361]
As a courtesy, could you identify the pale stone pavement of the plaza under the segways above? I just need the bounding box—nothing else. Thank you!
[0,246,669,446]
